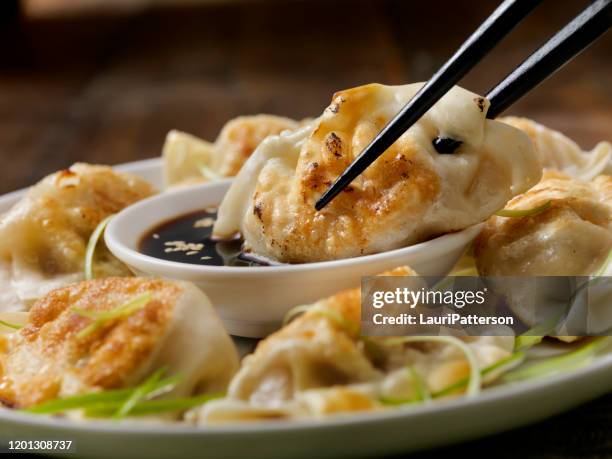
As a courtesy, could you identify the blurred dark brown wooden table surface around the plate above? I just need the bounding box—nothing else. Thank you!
[0,0,612,458]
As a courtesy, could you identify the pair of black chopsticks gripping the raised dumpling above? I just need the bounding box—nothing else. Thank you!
[315,0,612,210]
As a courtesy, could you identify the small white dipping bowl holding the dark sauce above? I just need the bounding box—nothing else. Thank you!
[105,179,482,338]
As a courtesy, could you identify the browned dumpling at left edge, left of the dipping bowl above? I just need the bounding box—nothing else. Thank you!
[0,163,154,311]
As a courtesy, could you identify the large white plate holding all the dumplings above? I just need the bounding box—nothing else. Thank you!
[0,160,612,459]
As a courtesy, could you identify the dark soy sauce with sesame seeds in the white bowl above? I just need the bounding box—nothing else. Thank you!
[138,208,267,266]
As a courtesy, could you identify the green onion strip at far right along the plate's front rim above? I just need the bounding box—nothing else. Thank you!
[502,336,608,382]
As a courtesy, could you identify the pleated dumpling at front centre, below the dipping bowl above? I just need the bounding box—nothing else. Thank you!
[194,267,514,424]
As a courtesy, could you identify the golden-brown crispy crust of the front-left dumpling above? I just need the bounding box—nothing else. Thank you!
[0,278,181,407]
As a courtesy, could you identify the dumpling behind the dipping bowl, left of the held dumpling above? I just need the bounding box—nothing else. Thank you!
[162,115,298,187]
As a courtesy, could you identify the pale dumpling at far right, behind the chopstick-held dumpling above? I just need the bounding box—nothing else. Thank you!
[499,116,612,180]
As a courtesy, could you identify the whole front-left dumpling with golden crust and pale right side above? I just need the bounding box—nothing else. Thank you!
[0,277,238,408]
